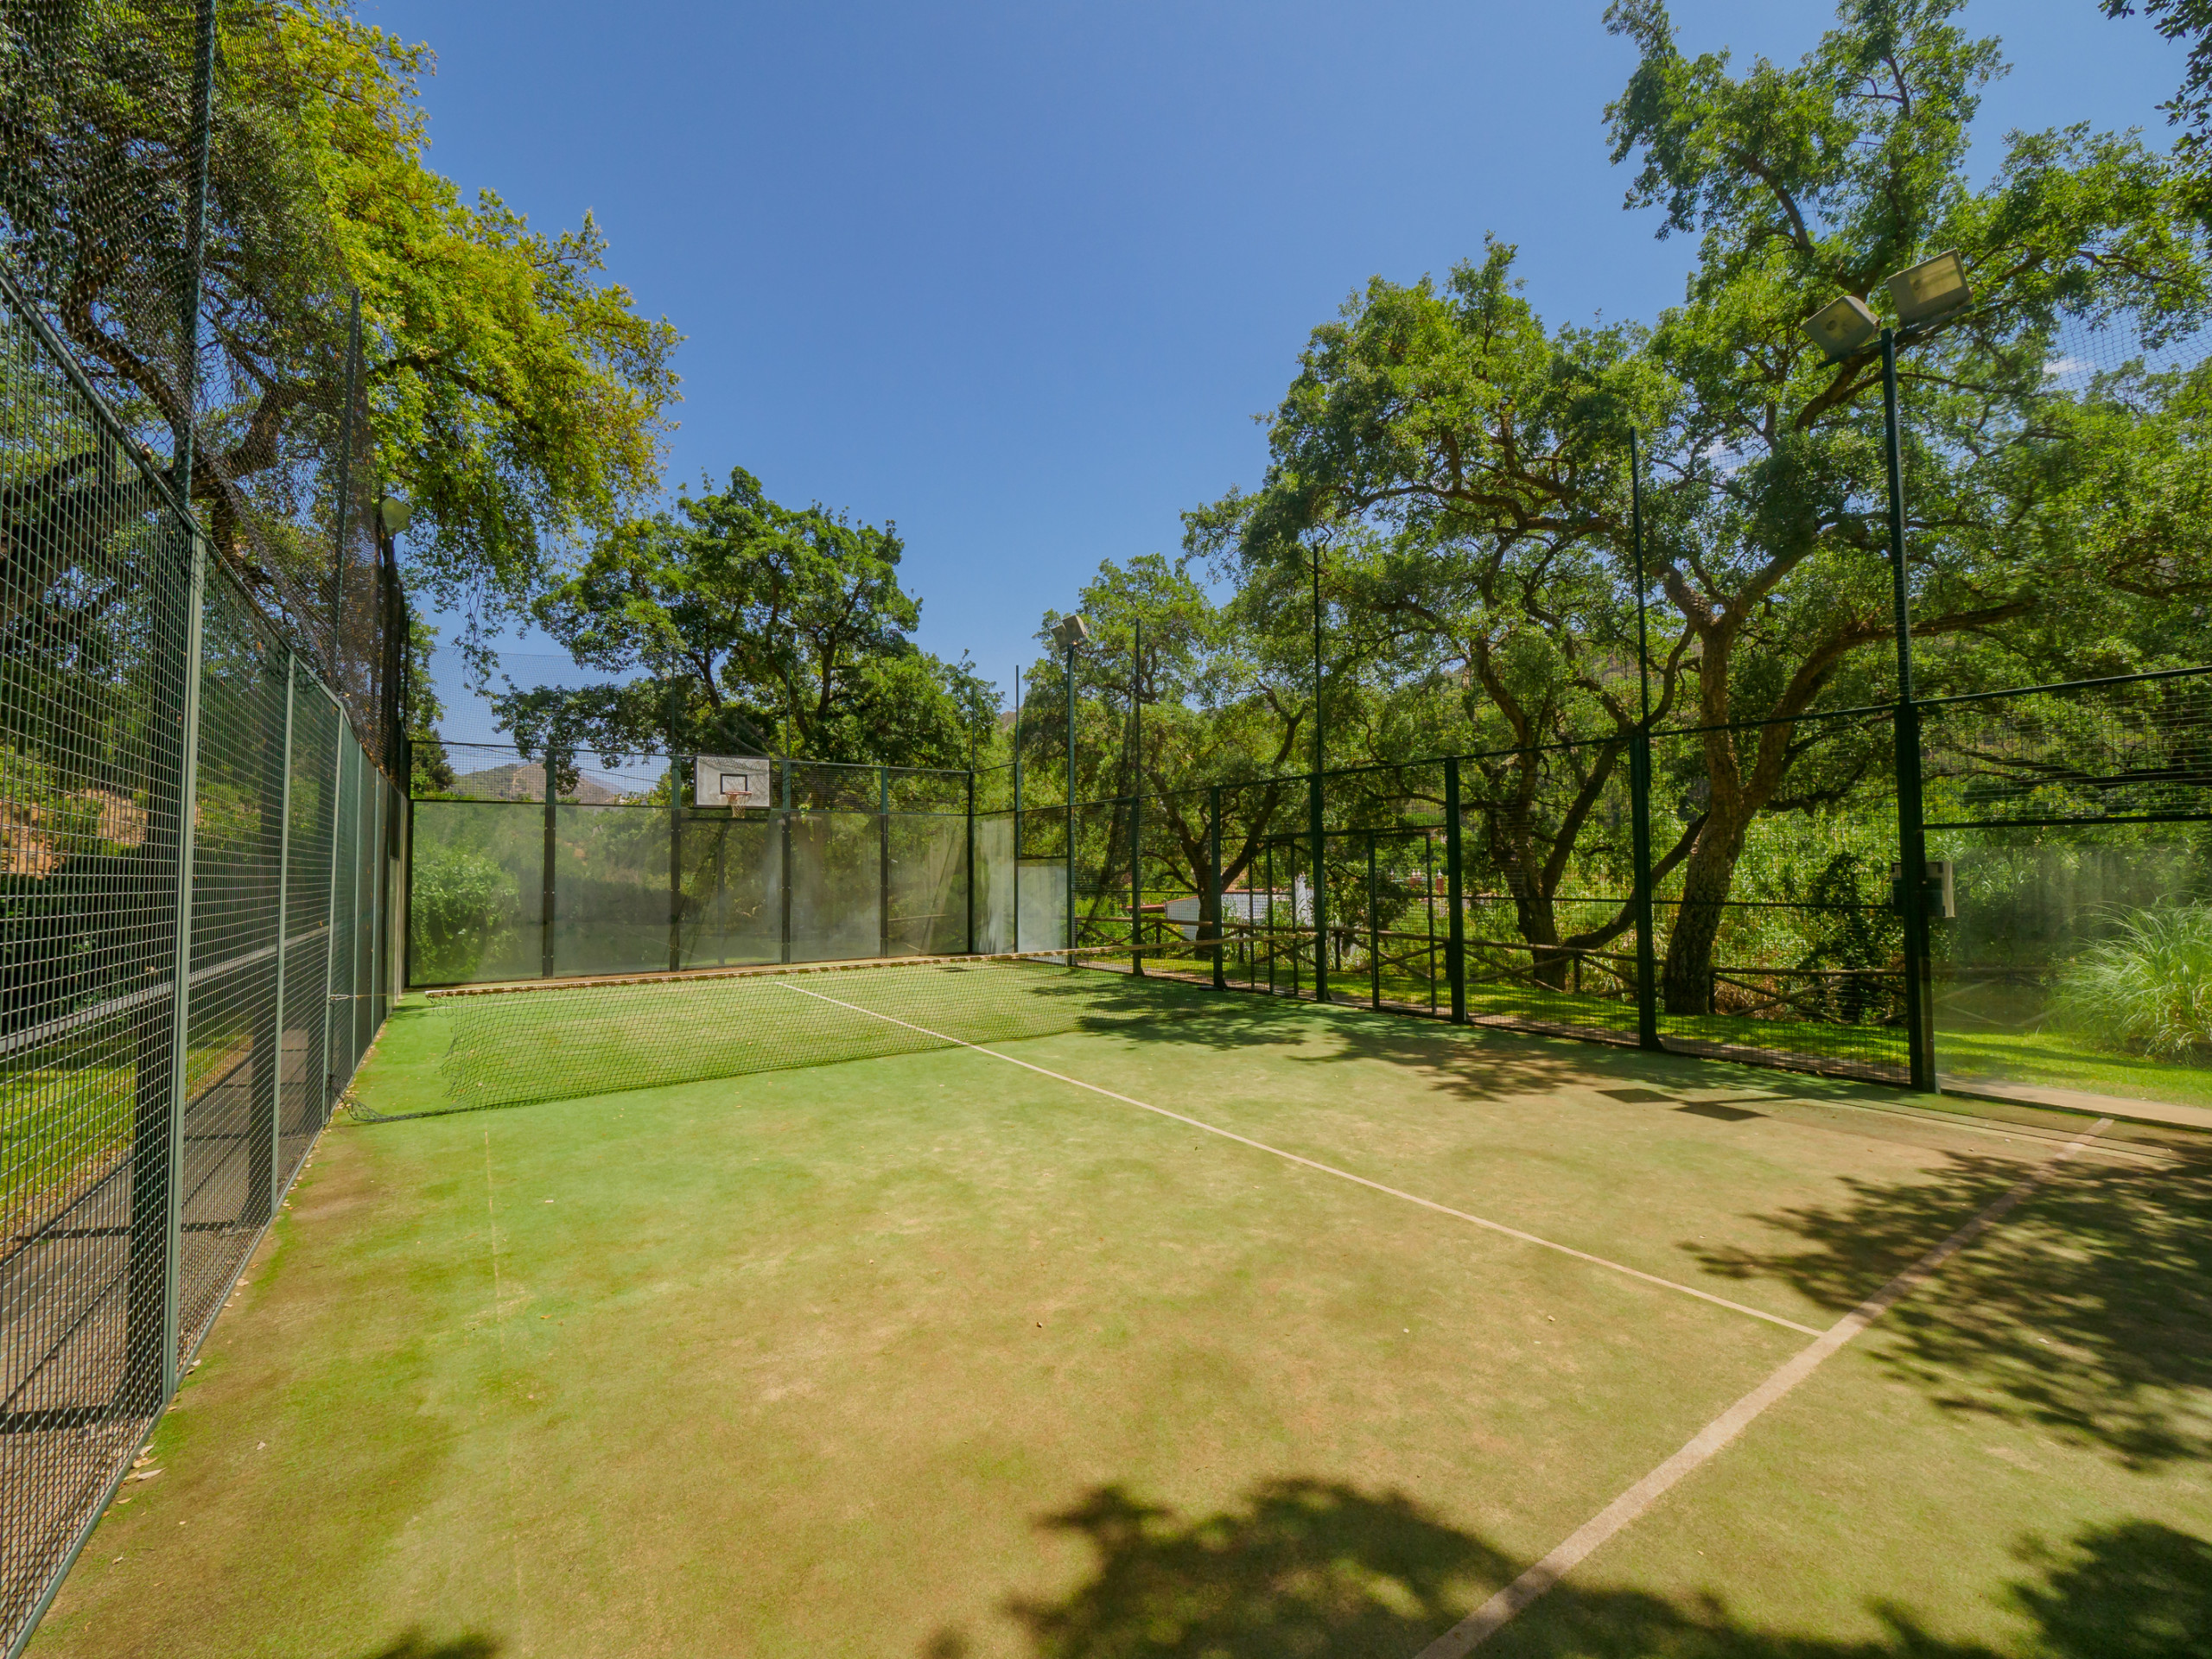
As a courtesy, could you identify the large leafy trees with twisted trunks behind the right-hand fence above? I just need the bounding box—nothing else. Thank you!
[1188,0,2212,1013]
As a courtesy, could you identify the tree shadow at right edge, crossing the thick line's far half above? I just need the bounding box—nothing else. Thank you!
[1686,1157,2212,1468]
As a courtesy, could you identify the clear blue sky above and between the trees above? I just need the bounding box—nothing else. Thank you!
[360,0,2181,736]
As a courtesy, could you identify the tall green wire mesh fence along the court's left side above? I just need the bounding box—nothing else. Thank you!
[0,0,404,1652]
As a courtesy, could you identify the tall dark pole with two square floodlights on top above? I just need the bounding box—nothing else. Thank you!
[1805,252,1974,1093]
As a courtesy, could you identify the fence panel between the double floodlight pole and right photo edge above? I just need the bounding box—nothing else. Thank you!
[1923,672,2212,1106]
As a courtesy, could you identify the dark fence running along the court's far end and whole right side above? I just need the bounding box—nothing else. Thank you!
[411,668,2212,1132]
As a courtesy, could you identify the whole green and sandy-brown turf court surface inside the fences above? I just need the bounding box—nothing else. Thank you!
[31,967,2212,1659]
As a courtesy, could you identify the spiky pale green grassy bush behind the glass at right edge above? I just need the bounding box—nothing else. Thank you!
[2057,905,2212,1059]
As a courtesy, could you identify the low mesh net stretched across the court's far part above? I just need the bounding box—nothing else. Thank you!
[385,947,1190,1122]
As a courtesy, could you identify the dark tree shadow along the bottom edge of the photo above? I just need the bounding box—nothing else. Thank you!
[923,1480,2212,1659]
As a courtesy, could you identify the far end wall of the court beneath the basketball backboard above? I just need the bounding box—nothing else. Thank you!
[407,743,969,987]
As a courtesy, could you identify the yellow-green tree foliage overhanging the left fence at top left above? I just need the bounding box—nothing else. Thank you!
[0,0,677,617]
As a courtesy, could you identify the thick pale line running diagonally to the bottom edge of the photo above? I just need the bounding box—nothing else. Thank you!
[1415,1117,2113,1659]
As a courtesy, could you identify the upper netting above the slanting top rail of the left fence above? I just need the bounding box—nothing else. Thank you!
[0,0,398,767]
